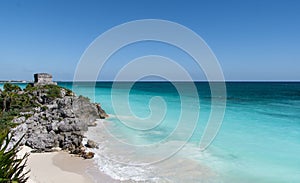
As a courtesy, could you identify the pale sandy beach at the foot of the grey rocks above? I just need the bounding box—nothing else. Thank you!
[18,146,118,183]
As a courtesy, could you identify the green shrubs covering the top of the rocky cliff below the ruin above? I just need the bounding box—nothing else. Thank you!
[0,83,73,134]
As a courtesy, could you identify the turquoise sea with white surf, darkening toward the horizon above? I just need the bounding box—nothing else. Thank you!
[0,82,300,183]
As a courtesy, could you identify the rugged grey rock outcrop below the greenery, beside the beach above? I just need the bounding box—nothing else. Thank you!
[14,86,107,154]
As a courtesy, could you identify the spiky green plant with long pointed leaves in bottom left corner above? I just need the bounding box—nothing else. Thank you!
[0,130,29,183]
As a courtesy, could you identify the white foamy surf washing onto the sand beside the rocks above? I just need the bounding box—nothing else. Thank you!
[86,121,163,182]
